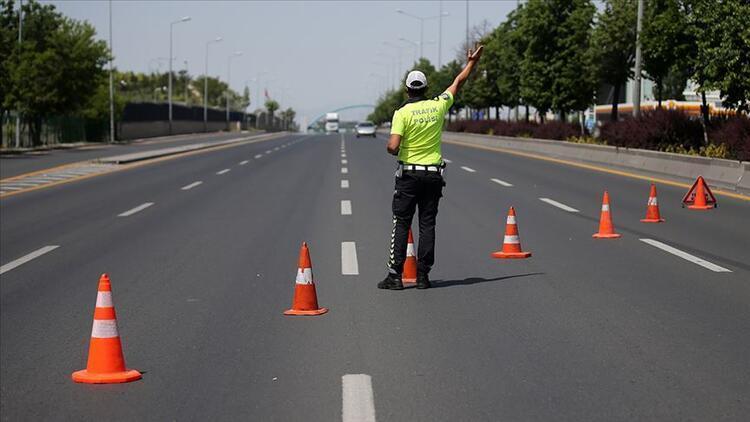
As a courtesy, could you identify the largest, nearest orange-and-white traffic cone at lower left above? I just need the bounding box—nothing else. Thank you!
[72,274,141,384]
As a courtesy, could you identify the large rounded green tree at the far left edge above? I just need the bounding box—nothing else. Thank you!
[0,0,109,145]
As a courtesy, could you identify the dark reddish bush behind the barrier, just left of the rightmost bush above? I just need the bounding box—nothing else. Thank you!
[600,110,703,151]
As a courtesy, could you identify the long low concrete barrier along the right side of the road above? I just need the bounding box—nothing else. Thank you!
[443,132,750,193]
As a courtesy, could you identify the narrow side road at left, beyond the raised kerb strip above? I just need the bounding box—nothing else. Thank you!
[0,132,253,179]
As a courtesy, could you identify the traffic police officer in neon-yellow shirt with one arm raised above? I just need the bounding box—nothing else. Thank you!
[378,45,483,290]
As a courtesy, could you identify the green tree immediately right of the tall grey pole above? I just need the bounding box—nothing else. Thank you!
[641,0,695,108]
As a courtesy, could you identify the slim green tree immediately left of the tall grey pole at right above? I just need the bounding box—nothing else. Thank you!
[591,0,636,121]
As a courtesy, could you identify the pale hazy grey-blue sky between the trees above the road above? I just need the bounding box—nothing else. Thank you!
[45,0,516,122]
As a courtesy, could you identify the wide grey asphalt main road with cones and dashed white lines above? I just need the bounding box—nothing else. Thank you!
[0,131,750,421]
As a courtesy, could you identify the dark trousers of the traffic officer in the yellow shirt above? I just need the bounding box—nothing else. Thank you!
[388,170,445,275]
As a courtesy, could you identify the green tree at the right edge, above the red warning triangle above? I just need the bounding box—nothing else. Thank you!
[686,0,750,113]
